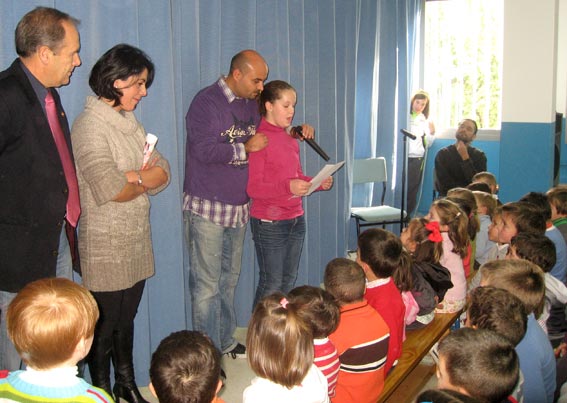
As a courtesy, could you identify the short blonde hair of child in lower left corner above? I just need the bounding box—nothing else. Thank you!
[6,278,99,370]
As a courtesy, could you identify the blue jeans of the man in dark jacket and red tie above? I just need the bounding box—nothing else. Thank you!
[0,226,73,371]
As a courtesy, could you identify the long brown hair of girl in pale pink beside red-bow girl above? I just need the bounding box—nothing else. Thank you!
[433,199,470,259]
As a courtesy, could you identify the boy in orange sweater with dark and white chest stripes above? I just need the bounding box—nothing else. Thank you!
[324,258,390,403]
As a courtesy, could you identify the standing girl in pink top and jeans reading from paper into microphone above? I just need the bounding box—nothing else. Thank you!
[247,80,333,305]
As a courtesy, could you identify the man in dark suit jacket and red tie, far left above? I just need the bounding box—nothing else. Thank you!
[0,7,81,370]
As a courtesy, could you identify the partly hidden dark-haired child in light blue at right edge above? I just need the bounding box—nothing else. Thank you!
[520,192,567,283]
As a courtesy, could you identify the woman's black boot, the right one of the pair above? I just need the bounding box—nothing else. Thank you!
[112,326,149,403]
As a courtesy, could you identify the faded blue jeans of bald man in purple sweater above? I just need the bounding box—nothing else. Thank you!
[183,211,246,353]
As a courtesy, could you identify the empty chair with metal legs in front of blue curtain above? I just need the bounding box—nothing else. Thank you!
[350,157,407,237]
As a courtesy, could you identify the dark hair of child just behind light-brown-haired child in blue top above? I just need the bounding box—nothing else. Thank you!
[508,232,557,273]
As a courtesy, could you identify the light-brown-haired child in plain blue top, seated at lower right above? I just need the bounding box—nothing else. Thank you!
[480,259,556,403]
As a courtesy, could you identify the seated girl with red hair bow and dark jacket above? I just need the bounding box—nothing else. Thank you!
[400,218,453,330]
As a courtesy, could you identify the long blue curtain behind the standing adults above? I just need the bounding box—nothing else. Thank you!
[0,0,421,384]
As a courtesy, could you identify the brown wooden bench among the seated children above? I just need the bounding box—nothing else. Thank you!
[378,312,461,403]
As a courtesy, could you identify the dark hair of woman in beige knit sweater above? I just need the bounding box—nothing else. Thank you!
[89,43,155,106]
